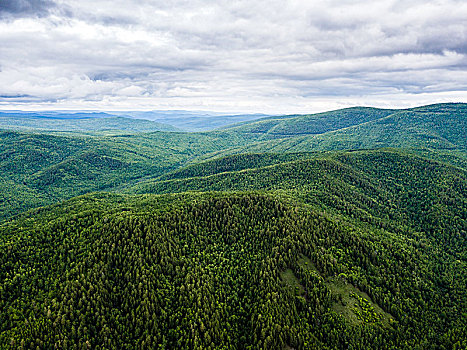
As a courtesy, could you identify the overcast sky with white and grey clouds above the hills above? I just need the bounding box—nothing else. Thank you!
[0,0,467,113]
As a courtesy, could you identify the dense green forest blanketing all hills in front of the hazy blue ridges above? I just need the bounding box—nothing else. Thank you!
[0,104,467,349]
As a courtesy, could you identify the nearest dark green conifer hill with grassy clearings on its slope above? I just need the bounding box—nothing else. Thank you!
[0,193,467,349]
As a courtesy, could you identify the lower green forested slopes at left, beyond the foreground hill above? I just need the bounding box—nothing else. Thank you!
[0,131,260,219]
